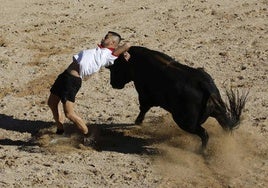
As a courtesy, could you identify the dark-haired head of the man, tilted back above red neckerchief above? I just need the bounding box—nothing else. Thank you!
[101,31,122,48]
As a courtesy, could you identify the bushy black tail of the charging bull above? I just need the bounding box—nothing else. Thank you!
[210,89,249,131]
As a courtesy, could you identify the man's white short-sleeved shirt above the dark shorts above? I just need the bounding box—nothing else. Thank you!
[73,45,117,78]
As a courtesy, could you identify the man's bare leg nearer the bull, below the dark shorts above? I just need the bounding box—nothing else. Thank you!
[63,100,88,134]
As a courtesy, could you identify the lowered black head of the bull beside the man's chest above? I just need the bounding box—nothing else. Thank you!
[107,54,132,89]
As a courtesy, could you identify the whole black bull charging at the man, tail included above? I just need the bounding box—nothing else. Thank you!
[108,46,247,149]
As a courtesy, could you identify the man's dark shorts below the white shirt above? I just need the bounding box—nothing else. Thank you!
[50,70,82,103]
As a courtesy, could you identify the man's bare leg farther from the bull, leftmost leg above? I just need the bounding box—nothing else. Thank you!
[47,93,64,131]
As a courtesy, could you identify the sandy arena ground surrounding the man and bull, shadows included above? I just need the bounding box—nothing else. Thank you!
[0,0,268,188]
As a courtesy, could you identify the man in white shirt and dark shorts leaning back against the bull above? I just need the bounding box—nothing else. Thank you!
[48,31,130,145]
